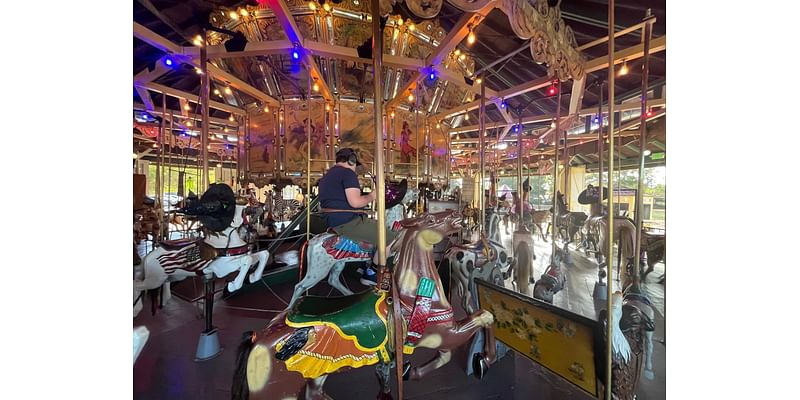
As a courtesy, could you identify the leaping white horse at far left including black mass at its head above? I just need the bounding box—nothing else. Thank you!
[134,184,269,316]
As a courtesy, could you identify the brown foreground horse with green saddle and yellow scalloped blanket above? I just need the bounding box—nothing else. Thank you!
[231,211,495,400]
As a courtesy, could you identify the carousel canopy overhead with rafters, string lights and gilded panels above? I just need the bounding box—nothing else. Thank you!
[133,0,666,174]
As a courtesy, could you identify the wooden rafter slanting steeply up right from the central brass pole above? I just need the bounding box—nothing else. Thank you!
[386,0,497,109]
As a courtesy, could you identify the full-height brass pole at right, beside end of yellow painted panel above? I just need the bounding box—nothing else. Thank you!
[600,0,619,399]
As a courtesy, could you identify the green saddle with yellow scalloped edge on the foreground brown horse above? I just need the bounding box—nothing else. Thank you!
[286,290,387,351]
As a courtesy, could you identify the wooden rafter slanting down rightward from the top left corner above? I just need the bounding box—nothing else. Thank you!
[133,22,280,105]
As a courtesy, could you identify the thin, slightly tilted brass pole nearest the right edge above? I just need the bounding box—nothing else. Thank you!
[633,8,652,286]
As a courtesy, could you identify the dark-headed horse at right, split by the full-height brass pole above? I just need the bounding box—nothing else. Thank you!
[578,185,636,287]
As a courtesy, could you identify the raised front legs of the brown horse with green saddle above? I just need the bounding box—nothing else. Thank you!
[409,310,494,380]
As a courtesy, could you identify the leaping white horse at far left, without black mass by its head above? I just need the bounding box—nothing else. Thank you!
[133,205,269,316]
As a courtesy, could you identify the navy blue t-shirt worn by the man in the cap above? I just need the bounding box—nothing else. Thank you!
[319,165,361,228]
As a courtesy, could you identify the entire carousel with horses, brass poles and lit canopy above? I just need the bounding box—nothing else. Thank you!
[133,0,666,399]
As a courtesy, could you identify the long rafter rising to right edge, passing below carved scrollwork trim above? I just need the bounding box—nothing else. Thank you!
[433,35,667,120]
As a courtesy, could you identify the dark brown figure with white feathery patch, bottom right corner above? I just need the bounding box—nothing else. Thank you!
[598,290,655,400]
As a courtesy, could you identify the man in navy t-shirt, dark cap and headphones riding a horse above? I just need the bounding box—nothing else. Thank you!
[319,148,397,285]
